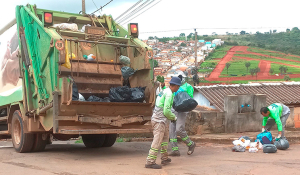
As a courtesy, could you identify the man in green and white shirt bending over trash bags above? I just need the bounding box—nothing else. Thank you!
[260,103,291,141]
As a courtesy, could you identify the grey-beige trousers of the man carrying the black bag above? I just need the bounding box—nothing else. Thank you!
[170,110,193,151]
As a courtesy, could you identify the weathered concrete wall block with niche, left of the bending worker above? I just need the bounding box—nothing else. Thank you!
[224,94,266,133]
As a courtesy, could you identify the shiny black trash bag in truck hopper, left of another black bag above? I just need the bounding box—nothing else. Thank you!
[109,86,132,102]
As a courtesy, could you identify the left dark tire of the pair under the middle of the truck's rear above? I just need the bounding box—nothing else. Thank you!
[82,134,105,148]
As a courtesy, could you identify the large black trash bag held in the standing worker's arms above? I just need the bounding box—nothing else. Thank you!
[173,92,198,112]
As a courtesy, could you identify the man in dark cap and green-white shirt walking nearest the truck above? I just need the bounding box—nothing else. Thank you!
[145,77,181,169]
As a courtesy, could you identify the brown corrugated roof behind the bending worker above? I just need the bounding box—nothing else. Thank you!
[194,82,300,111]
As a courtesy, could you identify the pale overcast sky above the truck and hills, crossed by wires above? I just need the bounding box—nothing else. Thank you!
[0,0,300,39]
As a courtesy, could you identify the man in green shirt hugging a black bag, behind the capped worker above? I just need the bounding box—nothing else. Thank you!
[169,75,196,156]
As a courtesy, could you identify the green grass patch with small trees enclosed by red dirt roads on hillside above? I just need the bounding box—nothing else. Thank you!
[220,60,259,77]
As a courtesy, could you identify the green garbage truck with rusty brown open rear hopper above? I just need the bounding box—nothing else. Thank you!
[0,5,155,153]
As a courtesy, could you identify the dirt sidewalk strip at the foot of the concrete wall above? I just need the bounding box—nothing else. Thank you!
[190,130,300,144]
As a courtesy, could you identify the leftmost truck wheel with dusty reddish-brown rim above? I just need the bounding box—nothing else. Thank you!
[11,110,34,153]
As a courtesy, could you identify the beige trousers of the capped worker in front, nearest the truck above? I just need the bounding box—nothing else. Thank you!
[146,121,169,164]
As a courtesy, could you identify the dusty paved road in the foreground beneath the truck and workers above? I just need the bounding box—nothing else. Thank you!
[0,141,300,175]
